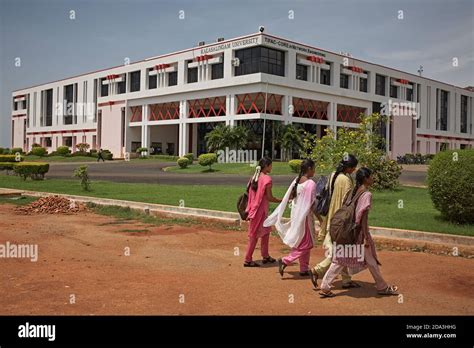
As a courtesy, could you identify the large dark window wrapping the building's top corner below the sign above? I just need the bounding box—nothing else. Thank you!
[235,46,285,76]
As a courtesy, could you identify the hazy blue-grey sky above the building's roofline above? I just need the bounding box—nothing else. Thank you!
[0,0,474,147]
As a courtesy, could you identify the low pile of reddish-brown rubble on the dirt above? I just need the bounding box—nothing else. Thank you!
[16,196,86,215]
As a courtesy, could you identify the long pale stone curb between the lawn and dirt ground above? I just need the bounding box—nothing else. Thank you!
[0,188,474,246]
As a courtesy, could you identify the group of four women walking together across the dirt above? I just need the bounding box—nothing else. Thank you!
[244,155,398,297]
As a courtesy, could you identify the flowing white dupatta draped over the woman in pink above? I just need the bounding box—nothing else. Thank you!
[263,179,316,248]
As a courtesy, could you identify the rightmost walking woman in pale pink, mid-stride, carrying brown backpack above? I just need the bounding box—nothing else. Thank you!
[319,167,398,297]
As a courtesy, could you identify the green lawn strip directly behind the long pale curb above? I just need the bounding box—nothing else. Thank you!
[0,175,474,236]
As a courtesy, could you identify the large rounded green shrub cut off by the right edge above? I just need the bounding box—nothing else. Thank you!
[427,150,474,223]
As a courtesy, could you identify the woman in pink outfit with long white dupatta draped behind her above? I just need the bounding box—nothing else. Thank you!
[263,159,316,276]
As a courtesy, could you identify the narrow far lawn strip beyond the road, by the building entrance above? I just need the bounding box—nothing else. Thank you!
[165,162,296,176]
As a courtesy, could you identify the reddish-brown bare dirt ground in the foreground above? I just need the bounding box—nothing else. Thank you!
[0,204,474,315]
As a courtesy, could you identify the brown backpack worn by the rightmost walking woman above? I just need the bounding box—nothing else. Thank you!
[329,190,365,245]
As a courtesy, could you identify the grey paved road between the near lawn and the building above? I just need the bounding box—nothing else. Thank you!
[47,160,426,186]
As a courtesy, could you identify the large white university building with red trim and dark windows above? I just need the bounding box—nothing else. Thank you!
[11,32,474,158]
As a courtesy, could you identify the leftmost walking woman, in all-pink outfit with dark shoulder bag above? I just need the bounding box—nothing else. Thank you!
[244,157,281,267]
